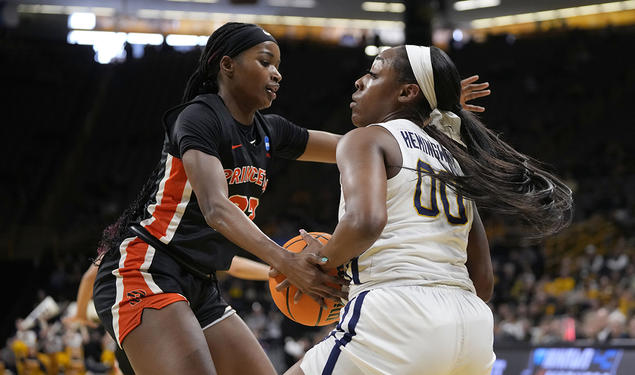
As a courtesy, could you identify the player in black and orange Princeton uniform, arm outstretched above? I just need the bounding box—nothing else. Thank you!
[94,23,487,374]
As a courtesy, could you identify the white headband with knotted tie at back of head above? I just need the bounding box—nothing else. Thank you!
[406,45,465,146]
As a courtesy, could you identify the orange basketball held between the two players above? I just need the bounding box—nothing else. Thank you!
[269,232,344,326]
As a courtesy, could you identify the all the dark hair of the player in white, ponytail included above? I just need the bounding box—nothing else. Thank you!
[392,46,573,239]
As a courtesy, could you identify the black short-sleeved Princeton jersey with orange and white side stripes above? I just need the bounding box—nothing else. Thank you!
[139,94,308,272]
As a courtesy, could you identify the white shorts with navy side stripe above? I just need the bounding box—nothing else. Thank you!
[300,286,496,375]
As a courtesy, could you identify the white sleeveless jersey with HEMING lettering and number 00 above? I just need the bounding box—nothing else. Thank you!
[339,119,475,298]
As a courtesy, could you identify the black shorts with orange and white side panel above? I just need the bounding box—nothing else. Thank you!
[93,236,234,346]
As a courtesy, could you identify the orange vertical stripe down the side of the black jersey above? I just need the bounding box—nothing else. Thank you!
[145,157,187,239]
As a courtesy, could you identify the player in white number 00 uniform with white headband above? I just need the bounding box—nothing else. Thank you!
[287,46,572,375]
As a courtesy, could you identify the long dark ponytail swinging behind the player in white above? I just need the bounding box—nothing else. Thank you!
[425,109,573,238]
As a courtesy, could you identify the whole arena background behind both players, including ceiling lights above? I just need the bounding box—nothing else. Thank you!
[0,0,635,375]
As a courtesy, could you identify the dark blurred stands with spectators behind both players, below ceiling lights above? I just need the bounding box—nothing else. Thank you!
[0,19,635,374]
